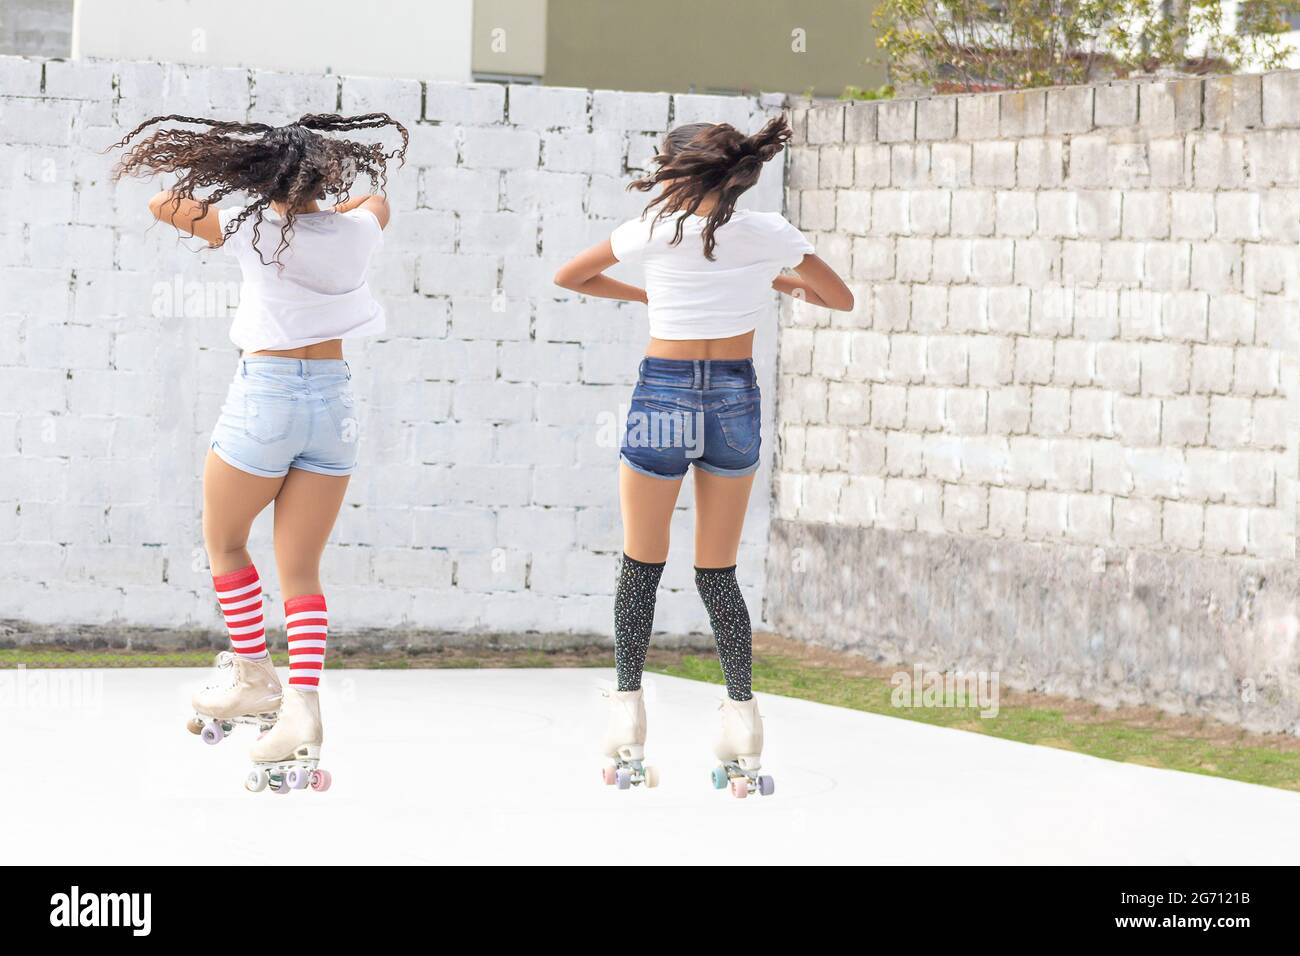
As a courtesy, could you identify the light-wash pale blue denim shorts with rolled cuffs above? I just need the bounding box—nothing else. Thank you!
[212,355,360,477]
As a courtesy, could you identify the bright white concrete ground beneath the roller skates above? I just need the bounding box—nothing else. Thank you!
[0,669,1300,865]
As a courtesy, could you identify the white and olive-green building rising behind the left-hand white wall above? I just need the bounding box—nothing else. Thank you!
[30,0,885,96]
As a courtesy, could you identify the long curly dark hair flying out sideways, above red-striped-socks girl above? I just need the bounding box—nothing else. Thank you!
[109,113,410,265]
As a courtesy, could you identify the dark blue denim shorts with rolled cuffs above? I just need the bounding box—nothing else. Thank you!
[619,358,762,479]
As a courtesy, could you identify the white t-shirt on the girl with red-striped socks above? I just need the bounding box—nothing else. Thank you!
[217,208,384,352]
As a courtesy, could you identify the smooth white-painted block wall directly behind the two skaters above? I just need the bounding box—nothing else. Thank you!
[0,57,785,633]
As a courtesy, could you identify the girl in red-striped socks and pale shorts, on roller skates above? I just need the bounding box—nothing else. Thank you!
[116,113,407,793]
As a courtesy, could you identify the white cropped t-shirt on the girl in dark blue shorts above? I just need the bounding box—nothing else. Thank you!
[610,209,813,338]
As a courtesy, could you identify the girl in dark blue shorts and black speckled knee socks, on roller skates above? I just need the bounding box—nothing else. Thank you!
[555,117,853,796]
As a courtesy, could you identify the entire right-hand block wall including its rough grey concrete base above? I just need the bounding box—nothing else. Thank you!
[766,73,1300,730]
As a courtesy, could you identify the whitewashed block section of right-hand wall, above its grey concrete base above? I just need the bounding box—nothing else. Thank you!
[775,80,1300,567]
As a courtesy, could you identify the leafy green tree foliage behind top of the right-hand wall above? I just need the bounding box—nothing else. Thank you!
[874,0,1300,91]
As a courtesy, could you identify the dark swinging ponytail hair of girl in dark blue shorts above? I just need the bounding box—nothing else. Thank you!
[628,116,792,260]
